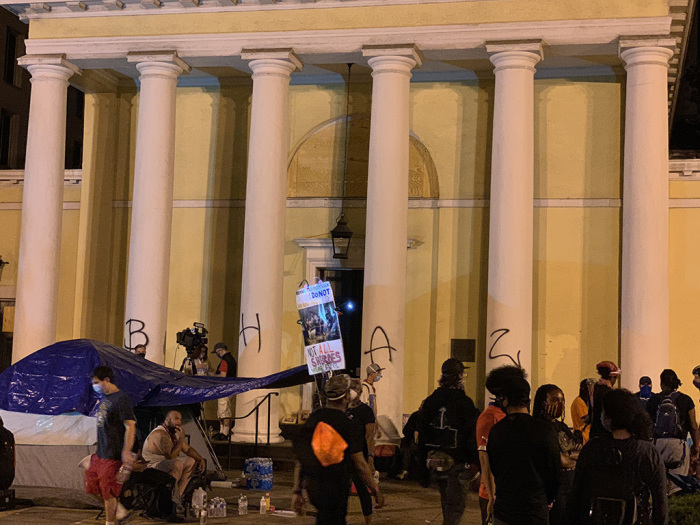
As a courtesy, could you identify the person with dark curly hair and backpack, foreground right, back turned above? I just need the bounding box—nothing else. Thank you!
[566,389,668,525]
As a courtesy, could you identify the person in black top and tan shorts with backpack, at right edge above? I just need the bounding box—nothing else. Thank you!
[647,369,700,476]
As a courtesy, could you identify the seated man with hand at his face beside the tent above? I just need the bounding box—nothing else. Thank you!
[141,410,206,504]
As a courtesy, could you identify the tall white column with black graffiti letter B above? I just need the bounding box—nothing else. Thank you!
[124,52,190,365]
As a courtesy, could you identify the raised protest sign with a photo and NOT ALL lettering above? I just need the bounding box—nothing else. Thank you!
[297,281,345,375]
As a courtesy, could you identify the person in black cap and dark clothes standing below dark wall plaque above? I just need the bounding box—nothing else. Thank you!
[418,358,479,525]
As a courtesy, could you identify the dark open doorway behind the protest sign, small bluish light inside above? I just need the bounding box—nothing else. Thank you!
[319,268,365,377]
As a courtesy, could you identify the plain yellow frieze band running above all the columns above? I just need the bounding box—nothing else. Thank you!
[29,0,668,39]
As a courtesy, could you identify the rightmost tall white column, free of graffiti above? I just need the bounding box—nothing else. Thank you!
[620,40,674,388]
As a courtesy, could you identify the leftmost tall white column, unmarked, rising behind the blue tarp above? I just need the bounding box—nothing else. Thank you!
[12,55,81,363]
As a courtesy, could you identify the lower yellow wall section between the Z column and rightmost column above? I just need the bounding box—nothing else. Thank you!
[531,208,620,422]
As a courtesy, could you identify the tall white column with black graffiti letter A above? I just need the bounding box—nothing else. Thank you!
[361,46,420,433]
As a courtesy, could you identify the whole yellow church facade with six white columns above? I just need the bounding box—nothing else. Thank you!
[0,0,700,440]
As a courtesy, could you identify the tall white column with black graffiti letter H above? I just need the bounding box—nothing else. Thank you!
[231,50,302,443]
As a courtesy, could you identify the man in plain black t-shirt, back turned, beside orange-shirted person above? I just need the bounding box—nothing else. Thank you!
[486,367,561,525]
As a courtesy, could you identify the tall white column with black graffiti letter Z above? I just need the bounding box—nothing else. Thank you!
[486,42,542,380]
